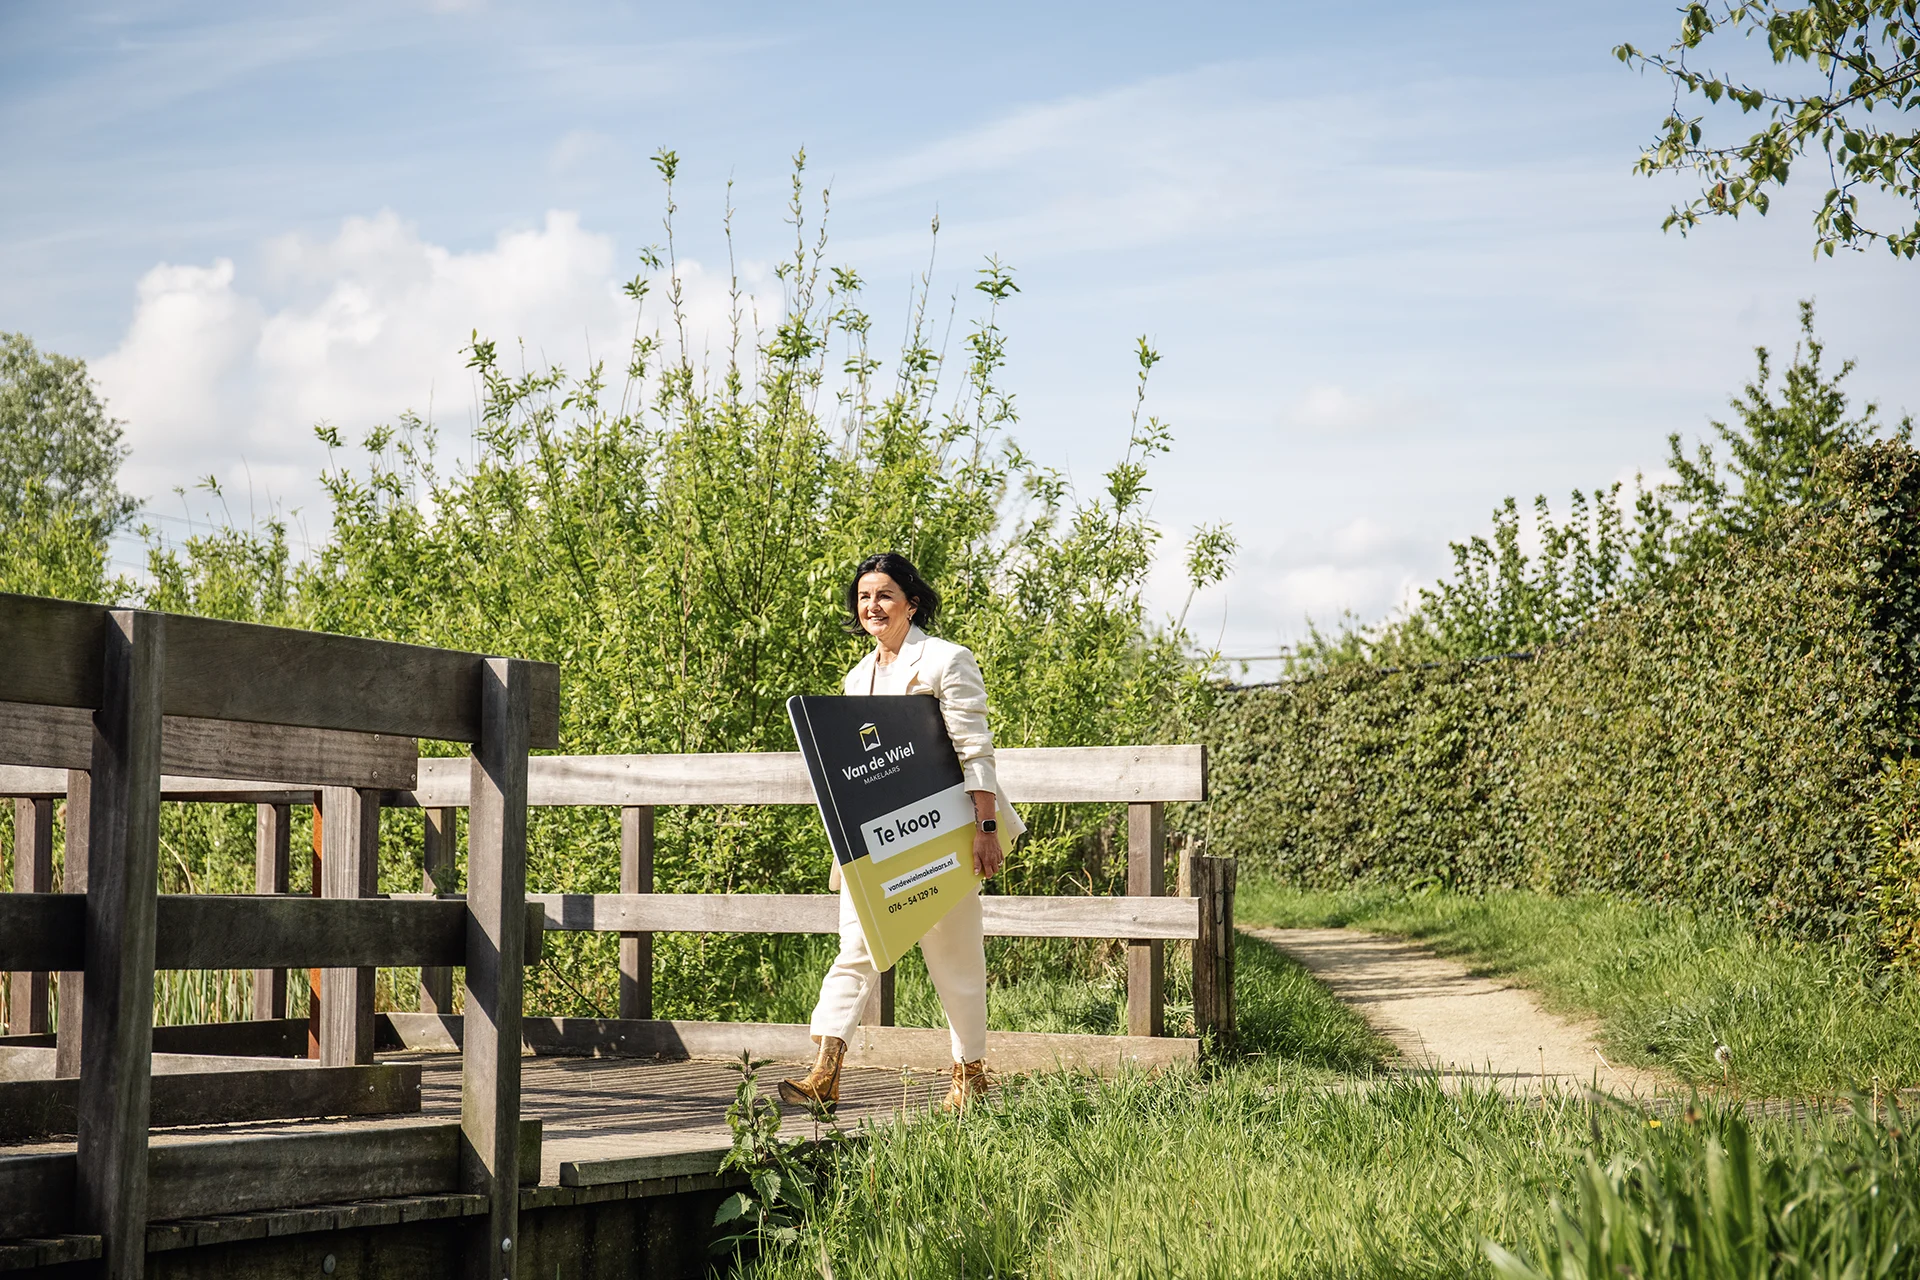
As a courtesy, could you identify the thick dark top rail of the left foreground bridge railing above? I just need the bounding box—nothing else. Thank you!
[0,595,561,748]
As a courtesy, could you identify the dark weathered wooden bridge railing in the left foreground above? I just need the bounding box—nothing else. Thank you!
[0,595,559,1280]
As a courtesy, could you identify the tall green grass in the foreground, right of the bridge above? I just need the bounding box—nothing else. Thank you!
[743,1067,1916,1280]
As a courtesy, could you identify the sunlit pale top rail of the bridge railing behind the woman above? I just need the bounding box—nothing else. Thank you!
[384,747,1206,808]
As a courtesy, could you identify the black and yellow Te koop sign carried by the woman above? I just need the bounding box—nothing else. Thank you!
[787,695,979,969]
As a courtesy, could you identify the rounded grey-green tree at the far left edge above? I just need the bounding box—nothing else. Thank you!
[0,334,138,541]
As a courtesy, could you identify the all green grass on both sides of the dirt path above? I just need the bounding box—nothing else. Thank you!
[710,885,1920,1280]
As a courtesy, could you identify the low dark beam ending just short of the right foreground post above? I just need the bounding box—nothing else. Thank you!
[0,1055,420,1142]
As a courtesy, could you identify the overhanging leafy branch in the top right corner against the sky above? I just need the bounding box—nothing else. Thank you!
[1613,0,1920,257]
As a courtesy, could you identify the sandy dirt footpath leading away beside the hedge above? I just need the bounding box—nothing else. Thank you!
[1244,929,1661,1098]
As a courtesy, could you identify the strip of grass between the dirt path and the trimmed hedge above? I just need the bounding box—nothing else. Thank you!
[1236,883,1920,1098]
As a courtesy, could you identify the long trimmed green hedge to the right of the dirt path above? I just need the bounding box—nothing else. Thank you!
[1208,441,1920,956]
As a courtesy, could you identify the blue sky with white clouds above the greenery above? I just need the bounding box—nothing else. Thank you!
[0,0,1920,675]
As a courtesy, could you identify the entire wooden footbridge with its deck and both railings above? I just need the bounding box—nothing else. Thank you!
[0,595,1233,1278]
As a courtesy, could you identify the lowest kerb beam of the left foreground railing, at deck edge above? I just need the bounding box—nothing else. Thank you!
[0,1119,540,1257]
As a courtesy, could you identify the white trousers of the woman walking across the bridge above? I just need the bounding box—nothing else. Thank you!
[812,887,987,1063]
